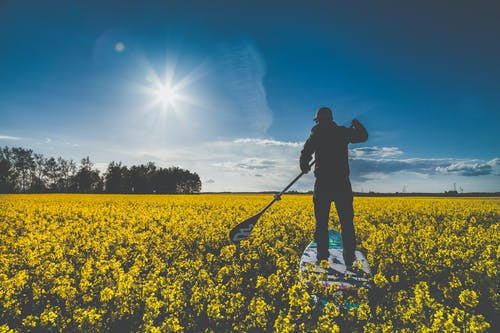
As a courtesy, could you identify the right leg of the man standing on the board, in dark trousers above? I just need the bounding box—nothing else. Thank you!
[335,181,356,267]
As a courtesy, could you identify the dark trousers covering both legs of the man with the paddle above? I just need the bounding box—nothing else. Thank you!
[313,178,356,266]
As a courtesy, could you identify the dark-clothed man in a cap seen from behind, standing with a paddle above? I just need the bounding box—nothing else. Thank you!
[300,107,368,268]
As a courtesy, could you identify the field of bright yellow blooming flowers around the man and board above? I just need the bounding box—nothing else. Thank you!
[0,194,500,332]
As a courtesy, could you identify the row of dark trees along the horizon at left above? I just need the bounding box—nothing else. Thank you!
[0,147,201,194]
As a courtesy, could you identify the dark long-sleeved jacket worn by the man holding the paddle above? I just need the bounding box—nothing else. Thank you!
[300,121,368,179]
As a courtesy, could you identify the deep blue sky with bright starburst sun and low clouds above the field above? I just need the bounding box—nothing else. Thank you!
[0,0,500,192]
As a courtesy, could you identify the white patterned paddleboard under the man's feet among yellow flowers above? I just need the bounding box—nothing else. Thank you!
[300,230,372,292]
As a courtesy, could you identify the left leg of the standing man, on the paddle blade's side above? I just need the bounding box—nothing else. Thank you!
[313,181,331,260]
